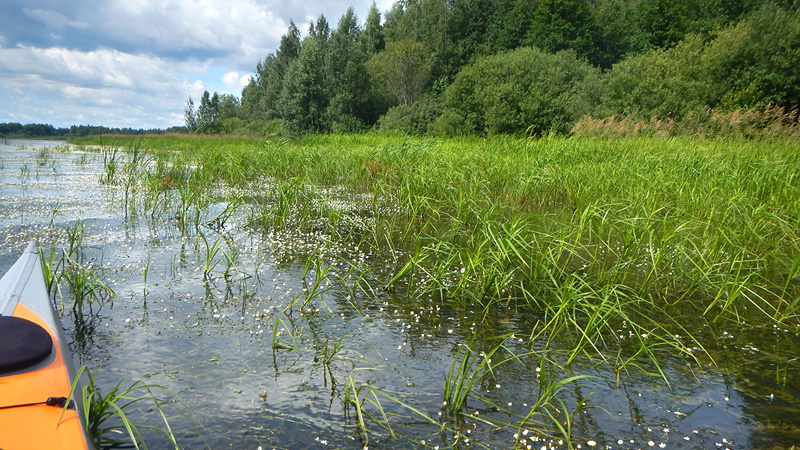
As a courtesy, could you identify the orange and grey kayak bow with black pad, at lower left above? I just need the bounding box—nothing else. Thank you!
[0,242,93,450]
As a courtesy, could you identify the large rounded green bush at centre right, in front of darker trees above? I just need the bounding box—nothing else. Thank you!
[445,47,598,135]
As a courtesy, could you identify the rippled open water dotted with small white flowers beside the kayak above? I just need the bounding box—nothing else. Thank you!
[0,140,800,450]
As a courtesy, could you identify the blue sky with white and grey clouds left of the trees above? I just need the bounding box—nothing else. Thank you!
[0,0,394,128]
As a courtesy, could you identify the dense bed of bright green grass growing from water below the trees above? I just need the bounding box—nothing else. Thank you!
[73,135,800,446]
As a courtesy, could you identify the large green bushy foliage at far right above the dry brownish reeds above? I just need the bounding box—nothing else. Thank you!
[595,5,800,120]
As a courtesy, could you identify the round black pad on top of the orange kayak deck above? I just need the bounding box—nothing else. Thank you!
[0,316,53,374]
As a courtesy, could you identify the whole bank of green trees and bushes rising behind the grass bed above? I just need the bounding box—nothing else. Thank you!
[186,0,800,135]
